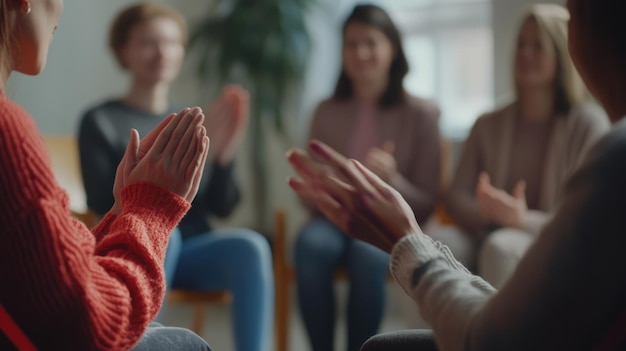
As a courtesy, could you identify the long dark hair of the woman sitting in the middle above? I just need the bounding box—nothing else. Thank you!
[333,4,409,107]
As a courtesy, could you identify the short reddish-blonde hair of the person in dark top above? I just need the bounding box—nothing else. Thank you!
[109,2,188,67]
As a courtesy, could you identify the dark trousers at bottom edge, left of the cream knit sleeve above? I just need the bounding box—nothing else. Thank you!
[361,329,437,351]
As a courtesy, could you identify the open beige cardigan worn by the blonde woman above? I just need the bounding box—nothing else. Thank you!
[445,104,610,238]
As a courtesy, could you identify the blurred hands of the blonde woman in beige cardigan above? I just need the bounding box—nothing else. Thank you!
[476,173,528,228]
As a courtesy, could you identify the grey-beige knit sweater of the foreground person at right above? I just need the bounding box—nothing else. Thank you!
[391,119,626,351]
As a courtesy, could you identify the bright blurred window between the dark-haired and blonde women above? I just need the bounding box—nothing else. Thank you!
[385,0,493,140]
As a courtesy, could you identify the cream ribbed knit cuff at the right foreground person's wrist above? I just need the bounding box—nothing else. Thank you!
[390,234,443,296]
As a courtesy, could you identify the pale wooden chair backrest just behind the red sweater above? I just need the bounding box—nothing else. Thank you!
[43,135,96,227]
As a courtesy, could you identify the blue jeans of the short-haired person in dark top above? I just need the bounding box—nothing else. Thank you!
[157,229,274,351]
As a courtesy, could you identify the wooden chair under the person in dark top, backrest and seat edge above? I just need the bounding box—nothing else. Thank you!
[43,135,232,335]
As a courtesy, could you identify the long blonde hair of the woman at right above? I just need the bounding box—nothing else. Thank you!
[516,4,591,113]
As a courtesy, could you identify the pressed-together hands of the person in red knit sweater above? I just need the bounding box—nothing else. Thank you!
[111,108,209,214]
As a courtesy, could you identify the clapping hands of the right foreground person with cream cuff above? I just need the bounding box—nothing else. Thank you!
[287,141,421,252]
